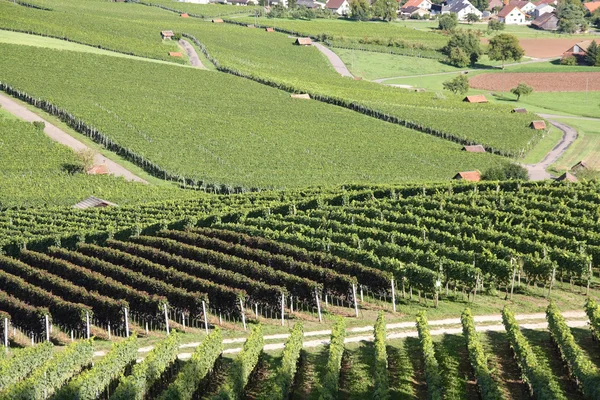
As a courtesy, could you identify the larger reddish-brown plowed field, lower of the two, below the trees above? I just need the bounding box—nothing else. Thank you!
[469,72,600,92]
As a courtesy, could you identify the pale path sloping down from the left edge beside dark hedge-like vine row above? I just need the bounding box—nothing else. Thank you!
[0,93,148,183]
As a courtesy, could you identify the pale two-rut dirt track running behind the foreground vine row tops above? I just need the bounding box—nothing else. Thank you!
[94,311,588,361]
